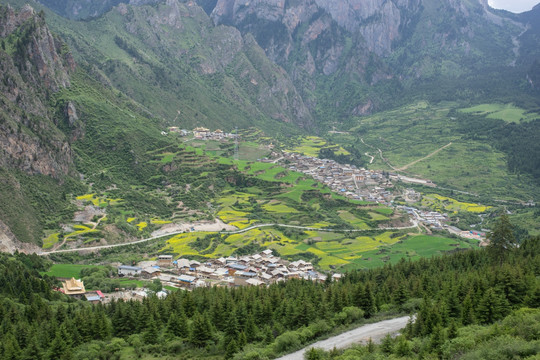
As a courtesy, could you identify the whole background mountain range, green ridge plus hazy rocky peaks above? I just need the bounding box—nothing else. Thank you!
[28,0,539,124]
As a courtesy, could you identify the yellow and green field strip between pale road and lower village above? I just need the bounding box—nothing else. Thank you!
[165,228,477,270]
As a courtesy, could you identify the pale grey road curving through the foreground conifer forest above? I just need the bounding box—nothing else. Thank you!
[277,316,410,360]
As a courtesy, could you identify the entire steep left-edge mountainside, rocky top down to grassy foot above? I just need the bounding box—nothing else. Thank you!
[0,6,82,246]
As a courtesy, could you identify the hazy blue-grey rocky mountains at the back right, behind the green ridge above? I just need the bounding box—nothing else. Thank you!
[205,0,534,121]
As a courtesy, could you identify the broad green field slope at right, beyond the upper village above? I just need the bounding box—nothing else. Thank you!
[342,102,539,201]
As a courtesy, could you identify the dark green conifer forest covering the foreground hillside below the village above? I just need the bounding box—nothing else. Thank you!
[0,215,540,359]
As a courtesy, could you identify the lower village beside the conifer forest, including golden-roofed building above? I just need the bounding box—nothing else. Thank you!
[59,249,332,303]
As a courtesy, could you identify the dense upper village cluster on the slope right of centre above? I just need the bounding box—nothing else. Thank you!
[261,152,394,205]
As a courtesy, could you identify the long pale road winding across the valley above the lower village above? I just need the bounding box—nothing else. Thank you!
[38,219,418,256]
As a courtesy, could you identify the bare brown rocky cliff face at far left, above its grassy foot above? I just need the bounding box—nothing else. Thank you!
[0,6,76,178]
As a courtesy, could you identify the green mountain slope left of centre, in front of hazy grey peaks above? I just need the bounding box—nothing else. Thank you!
[34,0,312,132]
